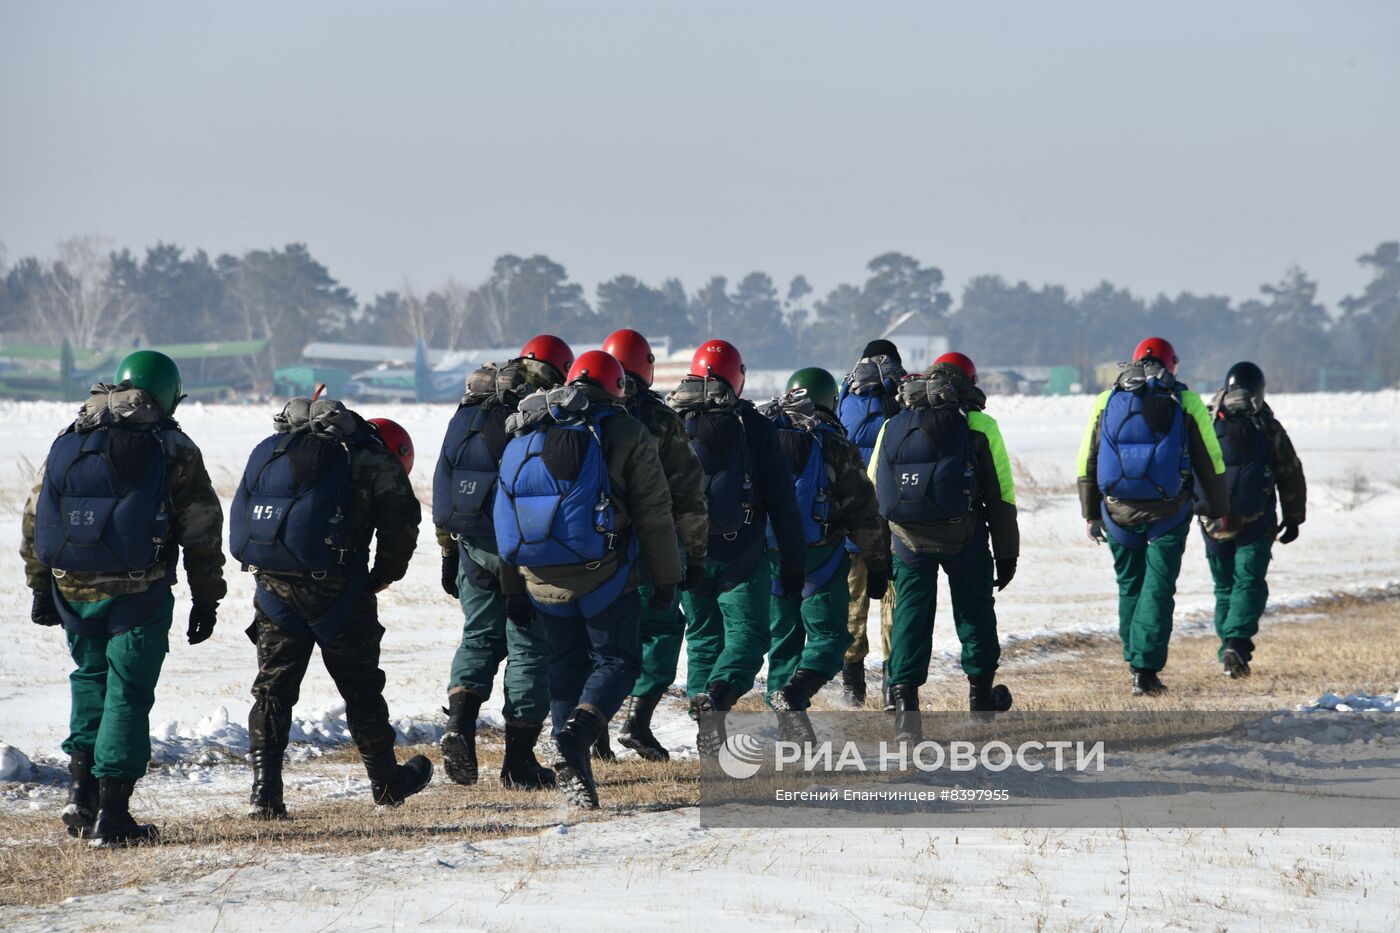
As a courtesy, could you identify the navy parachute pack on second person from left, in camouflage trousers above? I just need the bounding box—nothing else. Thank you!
[228,431,356,579]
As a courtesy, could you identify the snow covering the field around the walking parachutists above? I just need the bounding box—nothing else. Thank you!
[0,391,1400,929]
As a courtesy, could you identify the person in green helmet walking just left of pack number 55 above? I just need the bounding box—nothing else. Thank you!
[763,367,889,741]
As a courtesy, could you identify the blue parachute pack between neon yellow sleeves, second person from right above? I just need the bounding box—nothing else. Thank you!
[1098,363,1191,502]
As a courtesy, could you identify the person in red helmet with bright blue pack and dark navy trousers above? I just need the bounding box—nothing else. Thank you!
[493,350,682,810]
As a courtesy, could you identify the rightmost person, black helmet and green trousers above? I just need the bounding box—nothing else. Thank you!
[1198,361,1308,678]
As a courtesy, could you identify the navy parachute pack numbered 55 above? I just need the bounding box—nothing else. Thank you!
[875,371,977,539]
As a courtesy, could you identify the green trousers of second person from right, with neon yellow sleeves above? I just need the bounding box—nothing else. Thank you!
[1109,521,1190,671]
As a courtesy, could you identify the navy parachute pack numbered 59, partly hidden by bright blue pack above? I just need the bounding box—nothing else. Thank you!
[433,360,551,538]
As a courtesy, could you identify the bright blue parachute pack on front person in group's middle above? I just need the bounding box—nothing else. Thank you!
[493,409,637,618]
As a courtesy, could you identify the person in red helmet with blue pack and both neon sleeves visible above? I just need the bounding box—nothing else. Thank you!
[1078,338,1228,696]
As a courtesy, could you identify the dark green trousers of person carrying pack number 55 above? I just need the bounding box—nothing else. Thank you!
[886,551,1001,686]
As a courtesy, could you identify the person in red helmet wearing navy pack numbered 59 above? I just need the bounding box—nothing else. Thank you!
[433,333,574,790]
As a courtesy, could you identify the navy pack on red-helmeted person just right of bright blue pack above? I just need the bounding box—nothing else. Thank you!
[666,375,756,541]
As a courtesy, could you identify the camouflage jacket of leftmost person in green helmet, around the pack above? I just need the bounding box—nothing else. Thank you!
[20,387,228,604]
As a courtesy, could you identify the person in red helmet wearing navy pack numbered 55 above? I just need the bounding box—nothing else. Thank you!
[869,353,1021,722]
